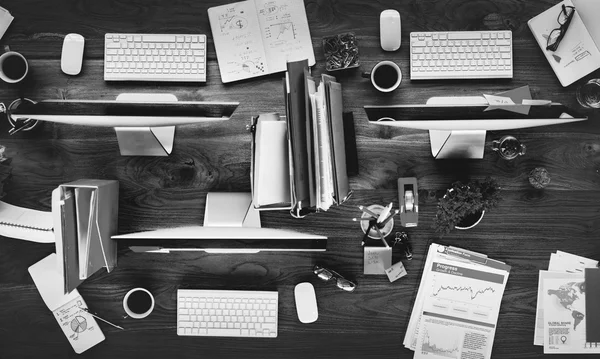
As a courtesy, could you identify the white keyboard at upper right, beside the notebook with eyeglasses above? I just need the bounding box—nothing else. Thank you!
[410,31,513,80]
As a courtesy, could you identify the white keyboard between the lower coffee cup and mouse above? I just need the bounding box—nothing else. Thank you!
[177,289,279,338]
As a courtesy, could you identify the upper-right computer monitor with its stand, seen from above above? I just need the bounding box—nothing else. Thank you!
[364,101,587,159]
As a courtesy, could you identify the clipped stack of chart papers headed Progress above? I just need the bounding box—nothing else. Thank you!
[404,243,510,359]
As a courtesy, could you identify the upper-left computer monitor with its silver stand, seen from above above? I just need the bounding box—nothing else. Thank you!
[10,94,239,156]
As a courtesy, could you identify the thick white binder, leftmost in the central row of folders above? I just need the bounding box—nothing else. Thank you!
[250,113,292,210]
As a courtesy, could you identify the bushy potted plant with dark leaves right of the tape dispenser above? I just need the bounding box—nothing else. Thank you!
[433,177,500,237]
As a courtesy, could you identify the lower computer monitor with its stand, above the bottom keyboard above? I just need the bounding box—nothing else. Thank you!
[111,192,327,254]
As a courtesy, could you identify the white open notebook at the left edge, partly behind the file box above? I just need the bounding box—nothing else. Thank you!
[0,201,55,243]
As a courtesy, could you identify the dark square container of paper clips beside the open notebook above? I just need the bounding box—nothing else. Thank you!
[323,32,360,71]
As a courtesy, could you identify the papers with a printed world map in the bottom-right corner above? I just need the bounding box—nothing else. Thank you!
[533,251,600,354]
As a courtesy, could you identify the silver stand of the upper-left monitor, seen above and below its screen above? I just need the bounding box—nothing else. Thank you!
[115,93,177,156]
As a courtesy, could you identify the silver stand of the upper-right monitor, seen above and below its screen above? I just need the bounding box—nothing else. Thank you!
[427,96,488,159]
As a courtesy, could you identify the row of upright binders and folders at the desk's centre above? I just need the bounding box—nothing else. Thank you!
[250,60,353,217]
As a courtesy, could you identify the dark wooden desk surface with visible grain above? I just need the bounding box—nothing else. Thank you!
[0,0,600,358]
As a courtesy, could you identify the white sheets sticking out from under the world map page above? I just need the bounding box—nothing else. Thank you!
[533,251,598,346]
